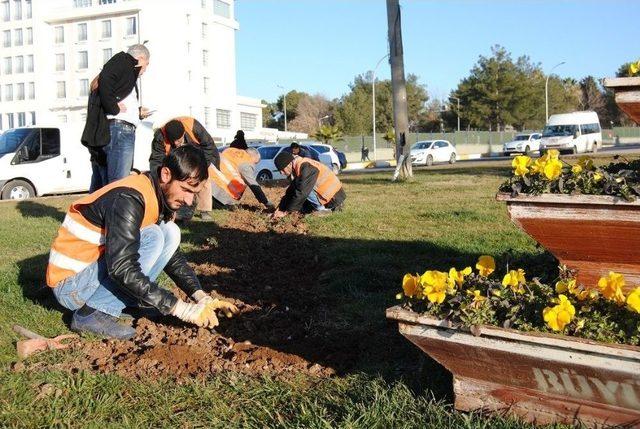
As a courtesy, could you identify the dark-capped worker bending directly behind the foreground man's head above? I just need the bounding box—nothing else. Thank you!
[149,116,220,220]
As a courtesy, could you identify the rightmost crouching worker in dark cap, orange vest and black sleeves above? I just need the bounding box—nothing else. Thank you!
[273,151,347,219]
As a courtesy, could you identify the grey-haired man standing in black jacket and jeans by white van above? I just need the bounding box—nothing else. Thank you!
[82,45,150,191]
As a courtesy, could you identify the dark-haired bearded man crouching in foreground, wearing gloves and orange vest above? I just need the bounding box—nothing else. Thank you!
[47,146,237,339]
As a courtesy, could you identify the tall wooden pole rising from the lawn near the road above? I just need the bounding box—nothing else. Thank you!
[387,0,413,180]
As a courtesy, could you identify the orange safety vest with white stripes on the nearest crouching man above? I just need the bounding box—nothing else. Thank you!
[47,174,160,287]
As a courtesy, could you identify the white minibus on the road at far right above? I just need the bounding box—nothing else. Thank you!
[540,112,602,153]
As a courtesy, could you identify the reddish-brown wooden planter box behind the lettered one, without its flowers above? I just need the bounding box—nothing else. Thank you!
[496,194,640,292]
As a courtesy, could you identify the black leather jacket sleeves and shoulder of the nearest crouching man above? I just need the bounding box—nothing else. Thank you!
[79,173,201,314]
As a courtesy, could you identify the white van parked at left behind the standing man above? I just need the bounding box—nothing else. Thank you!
[0,122,153,200]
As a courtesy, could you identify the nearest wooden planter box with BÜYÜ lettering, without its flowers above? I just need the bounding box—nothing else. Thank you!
[386,306,640,427]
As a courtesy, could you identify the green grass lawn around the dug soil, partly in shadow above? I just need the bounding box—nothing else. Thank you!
[0,164,568,428]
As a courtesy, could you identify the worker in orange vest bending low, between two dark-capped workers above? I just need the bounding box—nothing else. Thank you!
[209,147,275,210]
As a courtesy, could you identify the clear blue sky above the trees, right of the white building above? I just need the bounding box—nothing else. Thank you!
[235,0,640,102]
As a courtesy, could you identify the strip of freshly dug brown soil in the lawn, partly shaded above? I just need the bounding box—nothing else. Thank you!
[60,188,356,379]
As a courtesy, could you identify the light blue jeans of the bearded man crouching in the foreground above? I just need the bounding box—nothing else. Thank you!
[53,222,180,317]
